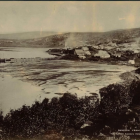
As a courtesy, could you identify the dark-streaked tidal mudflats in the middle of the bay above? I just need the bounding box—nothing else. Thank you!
[0,60,136,115]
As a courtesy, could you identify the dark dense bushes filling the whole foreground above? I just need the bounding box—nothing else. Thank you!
[0,69,140,140]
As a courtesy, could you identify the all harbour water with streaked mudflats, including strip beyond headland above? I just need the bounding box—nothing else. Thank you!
[0,48,135,115]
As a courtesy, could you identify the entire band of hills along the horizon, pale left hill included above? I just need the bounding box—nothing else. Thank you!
[0,28,140,48]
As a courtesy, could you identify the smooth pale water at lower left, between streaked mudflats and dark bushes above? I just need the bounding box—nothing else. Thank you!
[0,73,41,115]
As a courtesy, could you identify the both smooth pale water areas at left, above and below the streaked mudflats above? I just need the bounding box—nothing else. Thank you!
[0,47,54,115]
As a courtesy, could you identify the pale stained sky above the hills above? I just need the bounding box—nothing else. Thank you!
[0,1,140,34]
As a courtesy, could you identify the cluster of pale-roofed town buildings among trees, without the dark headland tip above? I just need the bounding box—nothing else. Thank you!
[65,42,140,66]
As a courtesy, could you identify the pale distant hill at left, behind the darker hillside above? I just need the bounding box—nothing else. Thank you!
[0,31,57,39]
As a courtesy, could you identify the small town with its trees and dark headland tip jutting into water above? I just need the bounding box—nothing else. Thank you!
[48,42,140,66]
